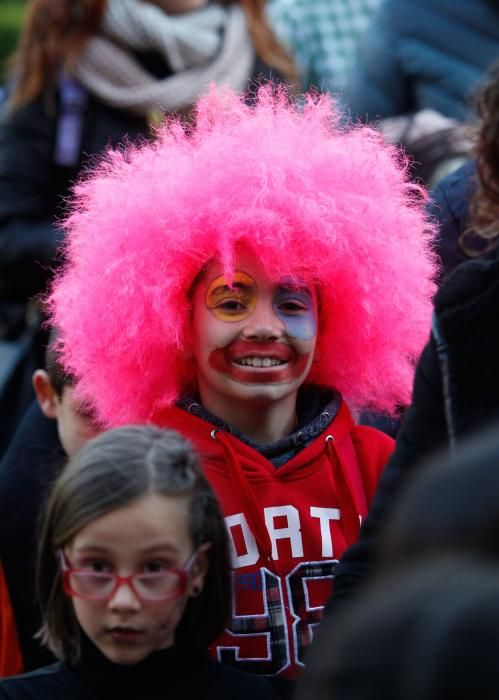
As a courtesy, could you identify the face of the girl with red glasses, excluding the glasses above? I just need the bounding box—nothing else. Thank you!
[64,494,206,664]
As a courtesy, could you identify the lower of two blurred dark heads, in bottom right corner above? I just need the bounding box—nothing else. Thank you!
[296,556,499,700]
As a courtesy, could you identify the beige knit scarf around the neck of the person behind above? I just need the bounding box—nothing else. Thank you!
[75,0,254,115]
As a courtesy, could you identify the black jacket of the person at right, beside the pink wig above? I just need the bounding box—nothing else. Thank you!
[328,246,499,613]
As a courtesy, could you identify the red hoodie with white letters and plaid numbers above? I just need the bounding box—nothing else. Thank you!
[154,402,393,678]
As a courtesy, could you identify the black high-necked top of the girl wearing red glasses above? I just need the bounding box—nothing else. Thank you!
[0,636,278,700]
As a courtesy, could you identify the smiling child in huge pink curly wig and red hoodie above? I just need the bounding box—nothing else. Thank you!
[50,88,434,679]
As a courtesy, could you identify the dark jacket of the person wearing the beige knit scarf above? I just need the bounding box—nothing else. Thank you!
[0,92,148,302]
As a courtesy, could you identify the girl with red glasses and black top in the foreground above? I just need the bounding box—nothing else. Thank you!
[0,427,274,700]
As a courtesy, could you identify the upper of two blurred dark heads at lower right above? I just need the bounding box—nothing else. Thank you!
[375,422,499,576]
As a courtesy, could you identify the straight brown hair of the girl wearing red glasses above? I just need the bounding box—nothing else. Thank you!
[37,426,231,662]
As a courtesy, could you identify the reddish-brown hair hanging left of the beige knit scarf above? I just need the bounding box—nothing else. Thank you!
[10,0,106,106]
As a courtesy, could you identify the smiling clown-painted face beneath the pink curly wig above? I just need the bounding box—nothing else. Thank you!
[189,256,317,416]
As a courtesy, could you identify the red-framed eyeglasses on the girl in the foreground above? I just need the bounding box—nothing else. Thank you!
[57,550,197,601]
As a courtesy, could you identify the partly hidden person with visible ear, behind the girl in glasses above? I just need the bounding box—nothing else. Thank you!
[0,331,100,678]
